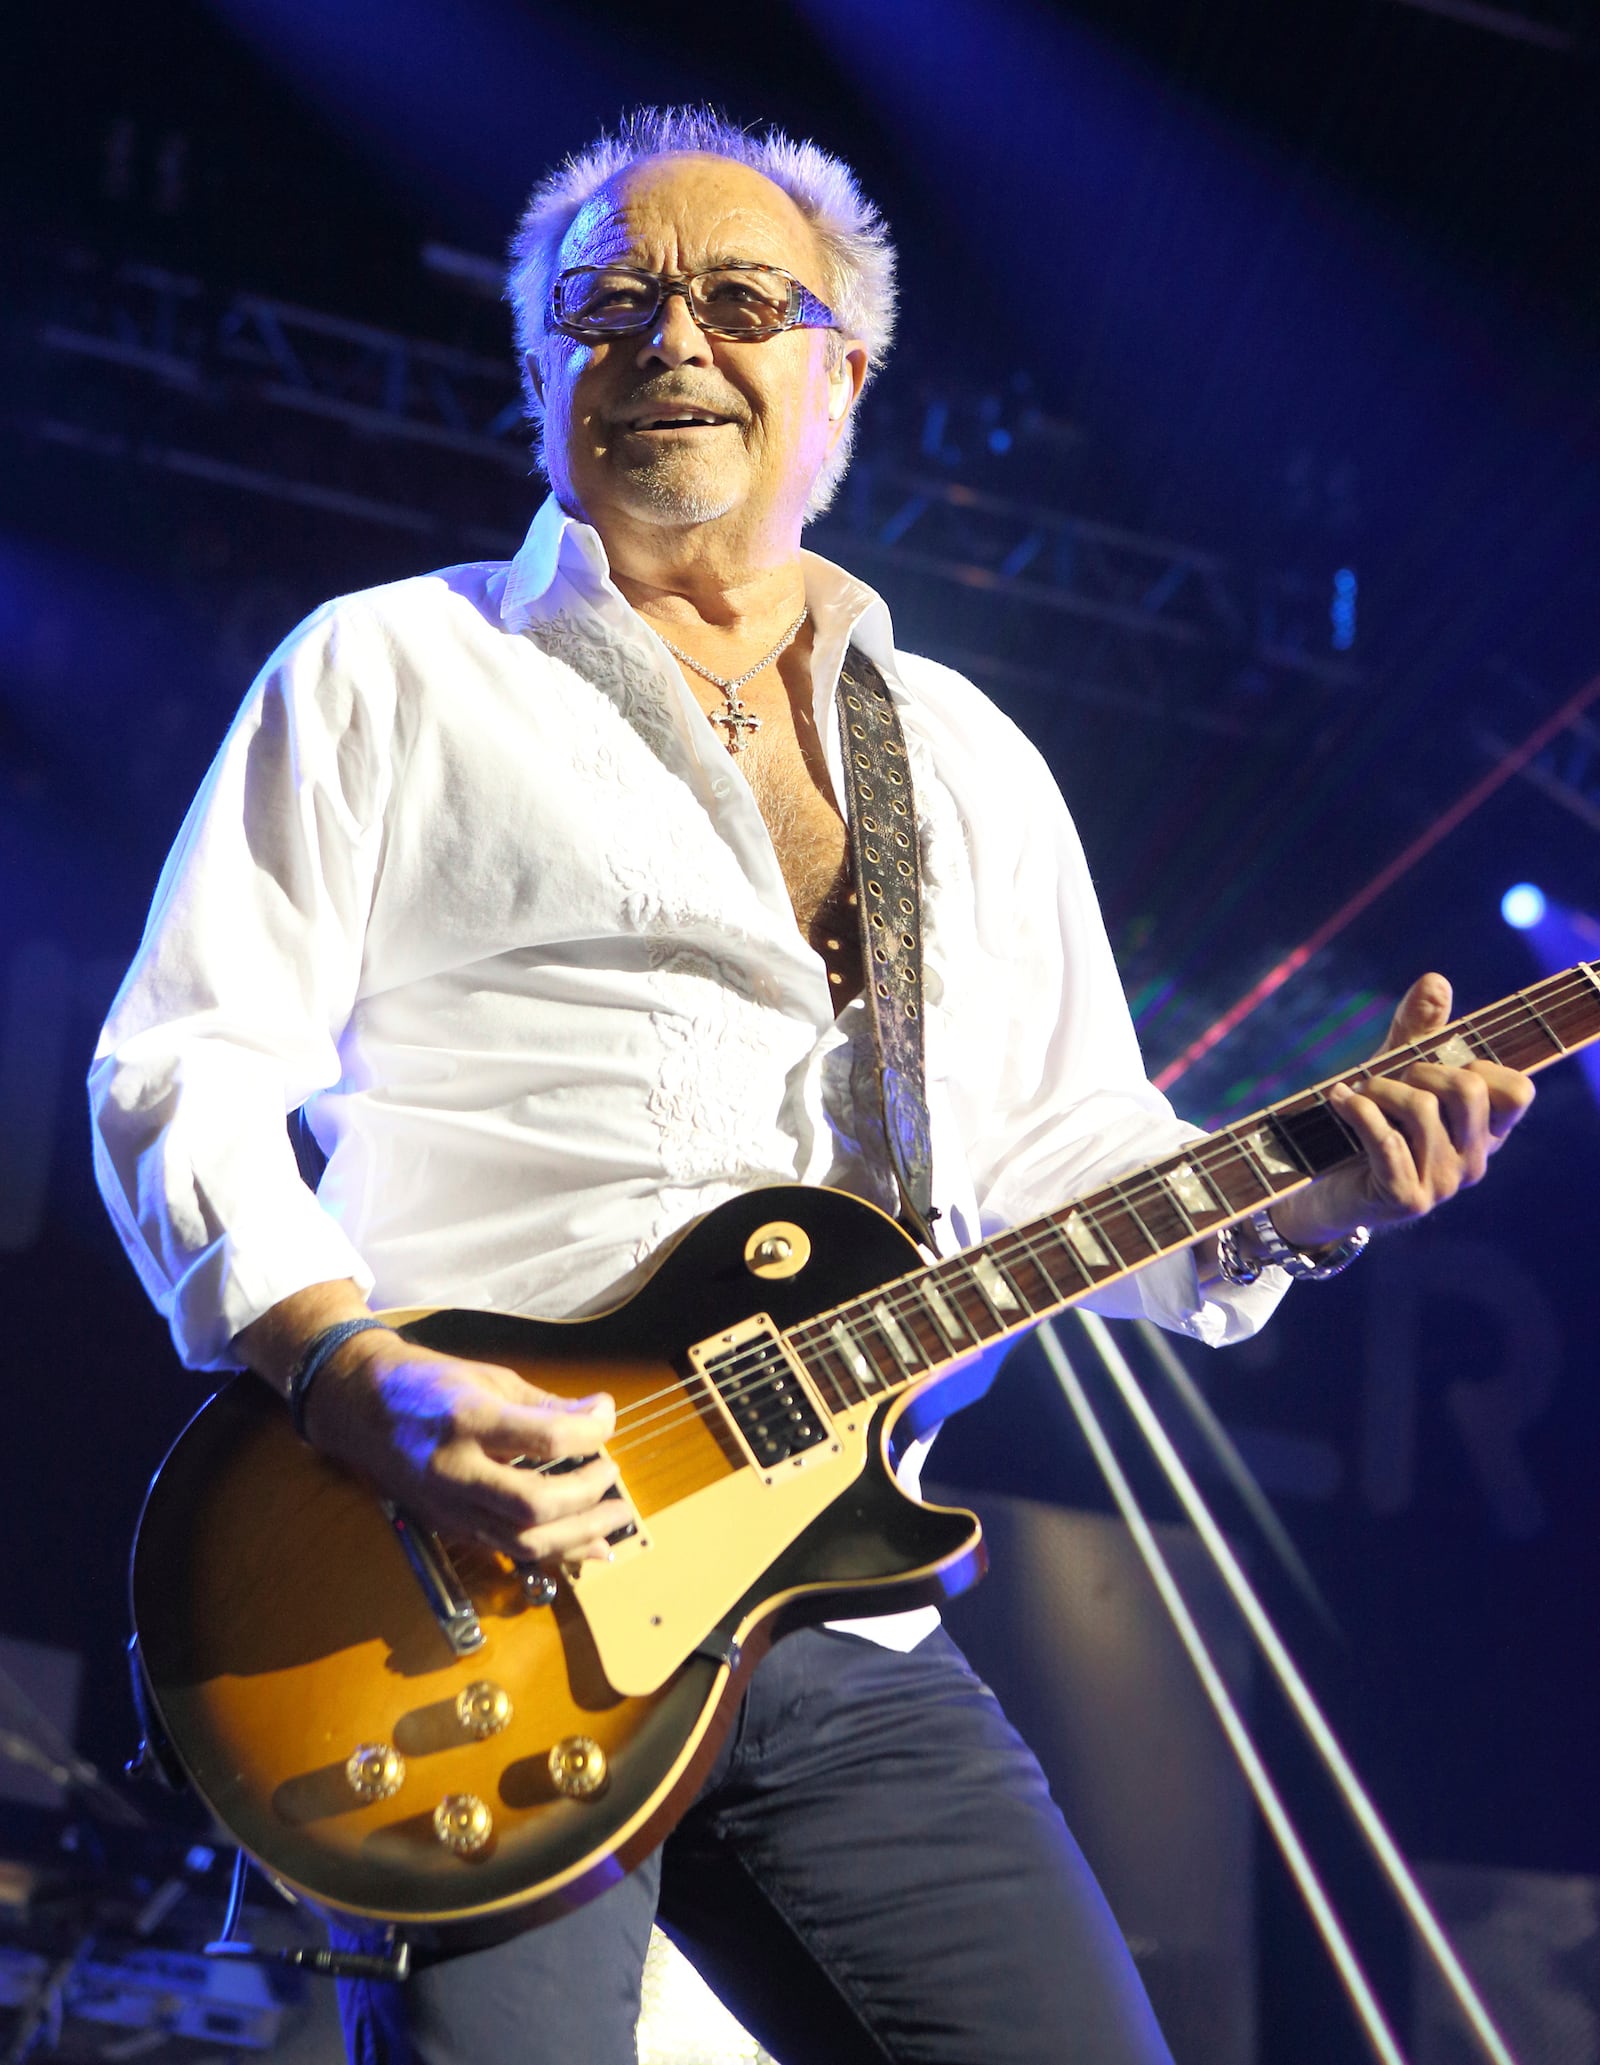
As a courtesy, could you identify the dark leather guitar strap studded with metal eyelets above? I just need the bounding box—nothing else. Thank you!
[838,646,939,1249]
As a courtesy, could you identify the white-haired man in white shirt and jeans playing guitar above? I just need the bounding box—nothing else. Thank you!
[93,114,1532,2065]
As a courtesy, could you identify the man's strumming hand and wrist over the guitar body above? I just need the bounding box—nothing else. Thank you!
[235,1282,634,1563]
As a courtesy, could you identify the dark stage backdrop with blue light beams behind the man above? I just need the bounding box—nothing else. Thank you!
[0,0,1600,2065]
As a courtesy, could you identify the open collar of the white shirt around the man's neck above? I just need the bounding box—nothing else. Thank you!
[500,496,894,681]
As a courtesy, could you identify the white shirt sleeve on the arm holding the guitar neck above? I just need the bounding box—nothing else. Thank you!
[949,725,1288,1346]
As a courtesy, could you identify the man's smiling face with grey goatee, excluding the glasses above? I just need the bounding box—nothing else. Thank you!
[535,157,865,539]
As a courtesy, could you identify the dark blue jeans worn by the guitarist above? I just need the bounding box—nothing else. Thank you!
[343,1629,1171,2065]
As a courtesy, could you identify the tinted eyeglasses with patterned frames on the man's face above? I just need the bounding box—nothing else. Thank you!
[547,264,838,343]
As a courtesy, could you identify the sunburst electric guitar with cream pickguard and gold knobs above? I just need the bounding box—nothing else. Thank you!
[132,962,1600,1933]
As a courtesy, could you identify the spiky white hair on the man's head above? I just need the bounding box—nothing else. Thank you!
[506,107,894,520]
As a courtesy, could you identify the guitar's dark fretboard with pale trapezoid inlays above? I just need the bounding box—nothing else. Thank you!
[785,962,1600,1410]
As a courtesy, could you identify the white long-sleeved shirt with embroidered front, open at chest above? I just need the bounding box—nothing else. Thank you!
[91,500,1282,1635]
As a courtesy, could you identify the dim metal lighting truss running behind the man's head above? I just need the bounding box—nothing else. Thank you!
[12,250,1361,731]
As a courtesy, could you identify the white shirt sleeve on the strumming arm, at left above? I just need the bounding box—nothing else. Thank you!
[89,605,394,1369]
